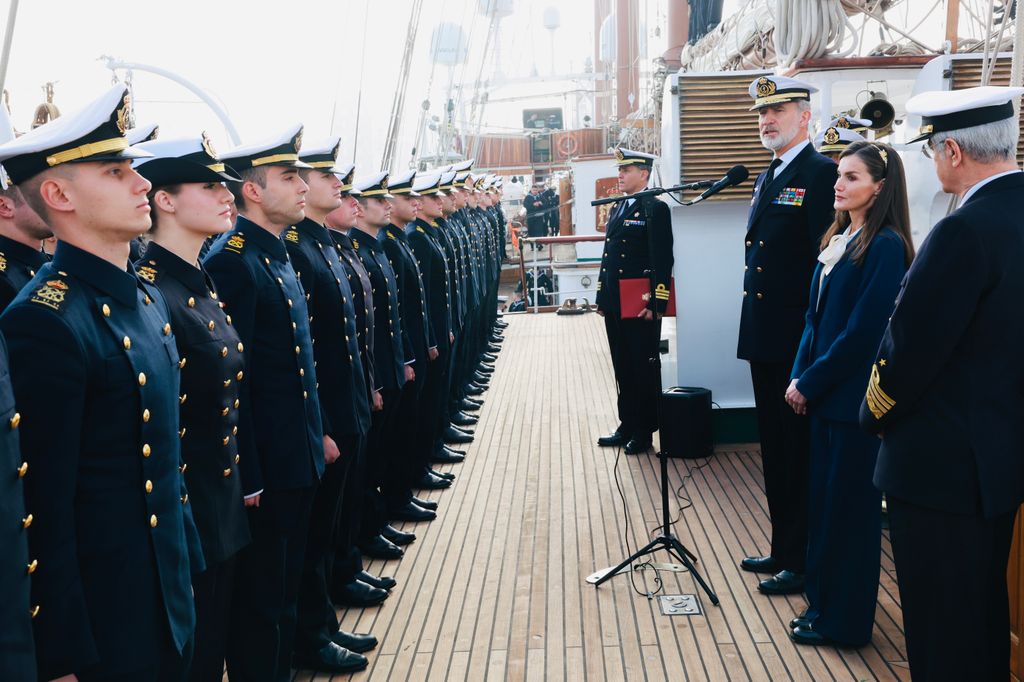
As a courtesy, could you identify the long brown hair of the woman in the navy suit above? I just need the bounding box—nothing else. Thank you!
[821,140,913,266]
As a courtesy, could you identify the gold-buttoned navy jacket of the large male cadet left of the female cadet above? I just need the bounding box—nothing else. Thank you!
[0,243,205,680]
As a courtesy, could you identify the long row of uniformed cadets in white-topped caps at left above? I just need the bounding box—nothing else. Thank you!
[0,86,504,680]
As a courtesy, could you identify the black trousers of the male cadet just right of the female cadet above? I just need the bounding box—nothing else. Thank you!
[227,486,314,682]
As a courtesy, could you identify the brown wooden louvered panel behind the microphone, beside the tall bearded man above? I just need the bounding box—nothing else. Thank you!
[679,74,771,201]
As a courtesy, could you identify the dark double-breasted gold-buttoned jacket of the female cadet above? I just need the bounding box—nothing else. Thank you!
[135,242,250,566]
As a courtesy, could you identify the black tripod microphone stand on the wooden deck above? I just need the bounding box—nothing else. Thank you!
[592,192,719,606]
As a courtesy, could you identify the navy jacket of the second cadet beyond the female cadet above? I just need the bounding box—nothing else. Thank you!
[284,218,370,439]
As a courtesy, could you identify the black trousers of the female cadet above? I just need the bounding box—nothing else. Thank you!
[188,554,238,682]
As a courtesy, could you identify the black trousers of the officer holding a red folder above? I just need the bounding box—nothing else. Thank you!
[604,311,662,439]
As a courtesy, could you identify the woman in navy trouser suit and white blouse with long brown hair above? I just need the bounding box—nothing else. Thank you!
[785,141,913,646]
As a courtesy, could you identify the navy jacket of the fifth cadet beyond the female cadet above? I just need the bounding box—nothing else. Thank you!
[382,225,437,364]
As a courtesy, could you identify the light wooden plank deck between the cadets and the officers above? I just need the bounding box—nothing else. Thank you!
[295,314,909,682]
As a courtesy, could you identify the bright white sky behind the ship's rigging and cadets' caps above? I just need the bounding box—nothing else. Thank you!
[0,0,618,172]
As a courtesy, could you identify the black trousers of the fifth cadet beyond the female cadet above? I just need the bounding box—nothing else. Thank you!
[381,372,421,511]
